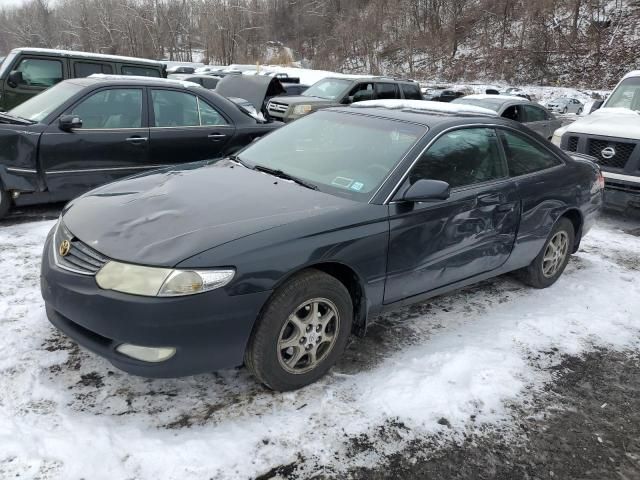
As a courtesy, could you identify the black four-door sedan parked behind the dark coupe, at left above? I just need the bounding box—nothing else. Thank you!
[0,75,281,217]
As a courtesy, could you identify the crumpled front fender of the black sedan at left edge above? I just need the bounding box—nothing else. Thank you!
[0,125,41,192]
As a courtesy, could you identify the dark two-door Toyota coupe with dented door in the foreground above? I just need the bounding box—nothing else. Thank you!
[42,102,603,390]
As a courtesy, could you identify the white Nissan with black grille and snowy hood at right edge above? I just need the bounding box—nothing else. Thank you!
[552,70,640,210]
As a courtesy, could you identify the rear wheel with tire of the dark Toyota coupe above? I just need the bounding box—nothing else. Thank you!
[517,217,575,288]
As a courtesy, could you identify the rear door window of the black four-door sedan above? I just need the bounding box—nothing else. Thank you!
[151,90,200,127]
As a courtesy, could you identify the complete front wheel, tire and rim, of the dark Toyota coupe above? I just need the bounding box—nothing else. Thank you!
[245,269,353,391]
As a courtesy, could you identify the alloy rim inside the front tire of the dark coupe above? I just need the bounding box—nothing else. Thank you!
[277,298,340,374]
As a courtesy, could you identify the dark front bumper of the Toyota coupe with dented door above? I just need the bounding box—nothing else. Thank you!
[41,236,271,377]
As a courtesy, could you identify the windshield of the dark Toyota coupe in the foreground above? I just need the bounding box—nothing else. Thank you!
[239,111,427,202]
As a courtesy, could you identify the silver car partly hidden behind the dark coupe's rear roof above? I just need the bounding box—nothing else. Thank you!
[452,95,562,140]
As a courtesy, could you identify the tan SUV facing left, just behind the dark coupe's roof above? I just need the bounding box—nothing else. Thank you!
[267,77,423,122]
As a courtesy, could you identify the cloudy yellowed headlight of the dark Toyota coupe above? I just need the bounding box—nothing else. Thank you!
[96,261,236,297]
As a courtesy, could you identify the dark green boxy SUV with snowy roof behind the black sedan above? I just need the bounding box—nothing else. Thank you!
[0,48,167,112]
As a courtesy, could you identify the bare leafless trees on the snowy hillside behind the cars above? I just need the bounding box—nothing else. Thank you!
[0,0,640,88]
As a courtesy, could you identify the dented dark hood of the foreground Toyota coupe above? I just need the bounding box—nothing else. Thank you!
[63,160,354,266]
